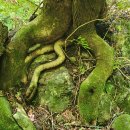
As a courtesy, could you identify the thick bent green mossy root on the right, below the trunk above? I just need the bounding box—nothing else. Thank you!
[78,33,114,122]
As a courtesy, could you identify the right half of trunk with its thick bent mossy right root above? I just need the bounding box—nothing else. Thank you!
[70,0,113,122]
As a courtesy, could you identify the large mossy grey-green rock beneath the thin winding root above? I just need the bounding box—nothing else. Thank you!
[38,67,74,112]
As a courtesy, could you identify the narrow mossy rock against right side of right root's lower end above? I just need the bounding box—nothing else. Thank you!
[97,81,117,125]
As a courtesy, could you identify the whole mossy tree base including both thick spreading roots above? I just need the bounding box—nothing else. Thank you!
[0,0,113,122]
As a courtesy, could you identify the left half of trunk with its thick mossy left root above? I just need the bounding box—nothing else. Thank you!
[0,0,71,89]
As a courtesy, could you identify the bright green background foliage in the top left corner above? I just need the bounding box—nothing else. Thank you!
[0,0,40,30]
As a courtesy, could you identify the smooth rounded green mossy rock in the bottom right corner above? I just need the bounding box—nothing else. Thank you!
[112,114,130,130]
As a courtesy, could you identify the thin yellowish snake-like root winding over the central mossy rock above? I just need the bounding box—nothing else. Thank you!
[26,40,65,101]
